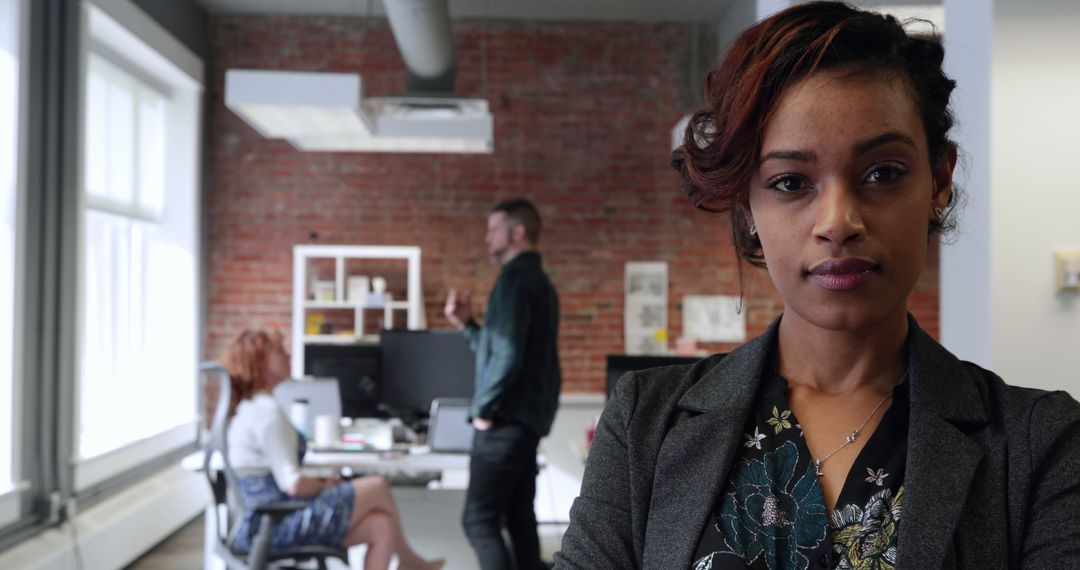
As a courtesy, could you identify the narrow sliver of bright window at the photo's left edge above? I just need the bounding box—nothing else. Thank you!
[0,0,22,494]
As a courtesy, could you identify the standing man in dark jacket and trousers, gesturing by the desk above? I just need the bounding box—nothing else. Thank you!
[445,200,563,570]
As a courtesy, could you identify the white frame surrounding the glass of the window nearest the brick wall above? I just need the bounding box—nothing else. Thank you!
[71,0,203,492]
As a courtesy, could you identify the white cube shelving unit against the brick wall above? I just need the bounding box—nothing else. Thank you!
[292,245,427,378]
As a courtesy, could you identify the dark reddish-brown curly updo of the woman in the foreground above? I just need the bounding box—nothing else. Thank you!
[672,2,956,267]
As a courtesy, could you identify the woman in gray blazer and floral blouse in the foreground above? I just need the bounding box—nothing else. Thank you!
[555,2,1080,570]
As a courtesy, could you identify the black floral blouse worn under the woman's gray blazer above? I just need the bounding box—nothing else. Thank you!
[692,374,908,570]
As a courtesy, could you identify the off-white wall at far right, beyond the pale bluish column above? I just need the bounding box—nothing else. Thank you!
[989,0,1080,397]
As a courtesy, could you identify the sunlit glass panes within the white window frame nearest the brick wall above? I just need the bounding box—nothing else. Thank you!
[79,55,176,458]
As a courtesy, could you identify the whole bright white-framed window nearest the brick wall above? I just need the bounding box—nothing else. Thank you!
[76,3,199,488]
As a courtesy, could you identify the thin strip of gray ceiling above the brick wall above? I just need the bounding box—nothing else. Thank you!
[198,0,746,22]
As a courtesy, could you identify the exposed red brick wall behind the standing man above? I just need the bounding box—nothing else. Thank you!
[205,16,937,392]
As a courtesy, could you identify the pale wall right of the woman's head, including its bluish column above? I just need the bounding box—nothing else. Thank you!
[942,0,1080,396]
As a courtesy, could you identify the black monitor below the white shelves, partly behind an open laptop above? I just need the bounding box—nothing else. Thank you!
[303,344,381,418]
